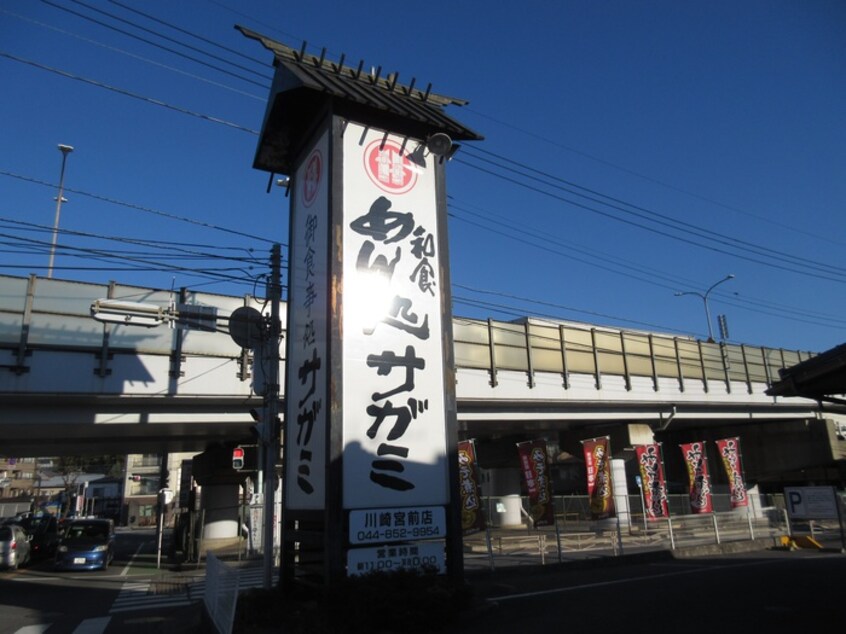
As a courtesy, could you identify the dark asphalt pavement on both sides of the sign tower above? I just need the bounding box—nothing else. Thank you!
[0,532,846,634]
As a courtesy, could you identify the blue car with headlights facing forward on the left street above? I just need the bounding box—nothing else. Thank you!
[55,519,115,570]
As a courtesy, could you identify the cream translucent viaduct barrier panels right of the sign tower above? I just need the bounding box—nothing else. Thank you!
[453,317,813,394]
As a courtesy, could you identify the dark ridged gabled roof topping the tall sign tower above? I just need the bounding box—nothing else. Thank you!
[235,26,483,174]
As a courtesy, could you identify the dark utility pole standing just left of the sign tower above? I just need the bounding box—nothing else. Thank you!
[261,244,282,590]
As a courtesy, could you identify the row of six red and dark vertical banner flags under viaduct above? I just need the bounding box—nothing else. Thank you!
[458,436,749,533]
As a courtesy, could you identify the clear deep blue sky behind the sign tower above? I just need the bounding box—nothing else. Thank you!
[0,0,846,352]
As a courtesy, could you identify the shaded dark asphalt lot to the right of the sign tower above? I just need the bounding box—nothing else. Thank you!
[449,550,846,634]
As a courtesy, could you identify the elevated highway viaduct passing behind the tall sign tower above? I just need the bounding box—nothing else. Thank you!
[0,276,846,502]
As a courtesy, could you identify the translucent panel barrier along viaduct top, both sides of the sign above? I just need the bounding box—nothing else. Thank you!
[0,275,813,394]
